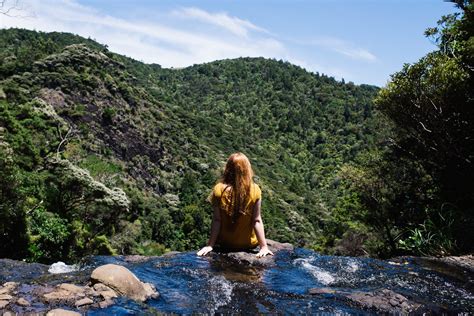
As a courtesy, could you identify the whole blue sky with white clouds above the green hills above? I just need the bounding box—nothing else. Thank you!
[0,0,456,86]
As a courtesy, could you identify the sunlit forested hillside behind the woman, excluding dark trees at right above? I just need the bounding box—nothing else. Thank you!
[0,29,379,260]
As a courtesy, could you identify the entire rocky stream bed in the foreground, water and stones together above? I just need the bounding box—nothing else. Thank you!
[0,241,474,315]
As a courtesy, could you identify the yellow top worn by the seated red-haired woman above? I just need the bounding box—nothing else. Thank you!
[210,183,262,249]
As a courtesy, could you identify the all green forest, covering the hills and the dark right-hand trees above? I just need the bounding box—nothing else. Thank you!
[0,1,474,262]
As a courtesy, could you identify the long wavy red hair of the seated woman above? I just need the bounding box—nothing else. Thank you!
[221,152,254,223]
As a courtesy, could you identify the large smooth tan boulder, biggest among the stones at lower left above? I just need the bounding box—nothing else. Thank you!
[91,264,158,302]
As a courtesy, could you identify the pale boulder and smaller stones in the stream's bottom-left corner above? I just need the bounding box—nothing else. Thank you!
[0,264,159,315]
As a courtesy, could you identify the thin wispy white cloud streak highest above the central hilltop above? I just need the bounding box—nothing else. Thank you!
[173,7,269,37]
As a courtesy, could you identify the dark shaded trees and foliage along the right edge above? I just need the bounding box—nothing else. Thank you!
[360,1,474,255]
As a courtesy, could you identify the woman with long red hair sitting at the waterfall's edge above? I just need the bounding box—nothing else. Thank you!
[197,153,273,257]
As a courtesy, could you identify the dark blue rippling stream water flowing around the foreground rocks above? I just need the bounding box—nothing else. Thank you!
[0,249,474,315]
